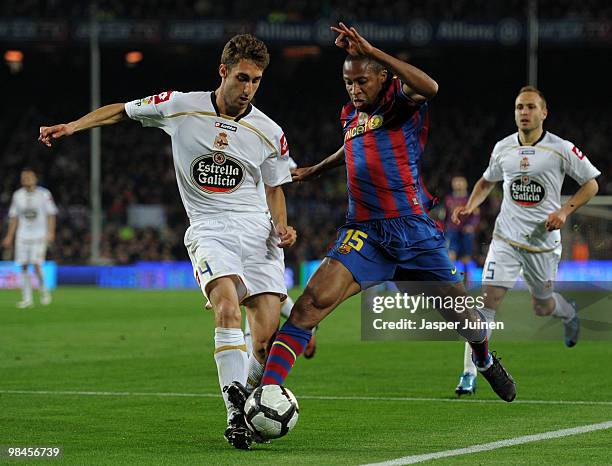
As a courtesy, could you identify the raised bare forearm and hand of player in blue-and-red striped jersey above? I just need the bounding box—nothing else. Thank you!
[331,23,438,101]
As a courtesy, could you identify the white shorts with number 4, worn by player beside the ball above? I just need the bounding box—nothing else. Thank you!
[185,213,287,301]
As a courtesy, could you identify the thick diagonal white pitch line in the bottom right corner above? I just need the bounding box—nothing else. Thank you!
[363,421,612,466]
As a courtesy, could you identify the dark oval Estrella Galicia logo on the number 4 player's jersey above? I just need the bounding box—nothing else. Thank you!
[191,152,245,194]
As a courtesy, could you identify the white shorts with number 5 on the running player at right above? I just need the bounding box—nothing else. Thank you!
[482,238,561,299]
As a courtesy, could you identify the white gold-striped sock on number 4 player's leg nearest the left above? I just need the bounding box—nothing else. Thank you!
[215,327,248,419]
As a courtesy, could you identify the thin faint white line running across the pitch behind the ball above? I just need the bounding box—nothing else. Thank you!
[0,390,612,406]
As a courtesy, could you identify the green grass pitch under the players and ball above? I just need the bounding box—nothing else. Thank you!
[0,288,612,466]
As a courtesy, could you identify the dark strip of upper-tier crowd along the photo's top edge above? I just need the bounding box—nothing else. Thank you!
[0,0,612,22]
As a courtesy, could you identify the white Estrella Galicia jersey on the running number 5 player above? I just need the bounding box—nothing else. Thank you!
[482,131,600,252]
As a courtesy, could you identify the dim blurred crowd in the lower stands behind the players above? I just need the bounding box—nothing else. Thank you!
[0,93,612,264]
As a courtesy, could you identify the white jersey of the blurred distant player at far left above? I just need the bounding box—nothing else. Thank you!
[9,186,57,241]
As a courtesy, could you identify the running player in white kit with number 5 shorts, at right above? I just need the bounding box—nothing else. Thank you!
[453,86,600,395]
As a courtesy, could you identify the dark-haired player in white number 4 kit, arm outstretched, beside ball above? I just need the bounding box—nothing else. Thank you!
[39,34,296,449]
